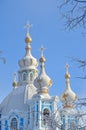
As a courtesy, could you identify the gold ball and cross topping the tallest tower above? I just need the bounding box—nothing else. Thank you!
[24,23,32,43]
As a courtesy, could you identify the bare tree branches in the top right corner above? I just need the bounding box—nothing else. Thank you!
[58,0,86,29]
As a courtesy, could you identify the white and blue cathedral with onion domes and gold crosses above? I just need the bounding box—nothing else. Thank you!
[0,24,79,130]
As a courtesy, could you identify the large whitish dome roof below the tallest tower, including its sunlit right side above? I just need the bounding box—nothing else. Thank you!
[0,86,36,115]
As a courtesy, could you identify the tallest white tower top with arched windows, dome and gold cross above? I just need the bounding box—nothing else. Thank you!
[18,24,38,85]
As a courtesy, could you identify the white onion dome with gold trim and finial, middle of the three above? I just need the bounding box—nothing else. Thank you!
[34,49,52,93]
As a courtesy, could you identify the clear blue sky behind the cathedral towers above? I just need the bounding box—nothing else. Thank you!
[0,0,86,101]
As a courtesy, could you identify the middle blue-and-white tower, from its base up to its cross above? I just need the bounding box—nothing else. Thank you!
[27,48,59,130]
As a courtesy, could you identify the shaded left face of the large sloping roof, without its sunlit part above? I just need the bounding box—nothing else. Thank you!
[0,86,27,114]
